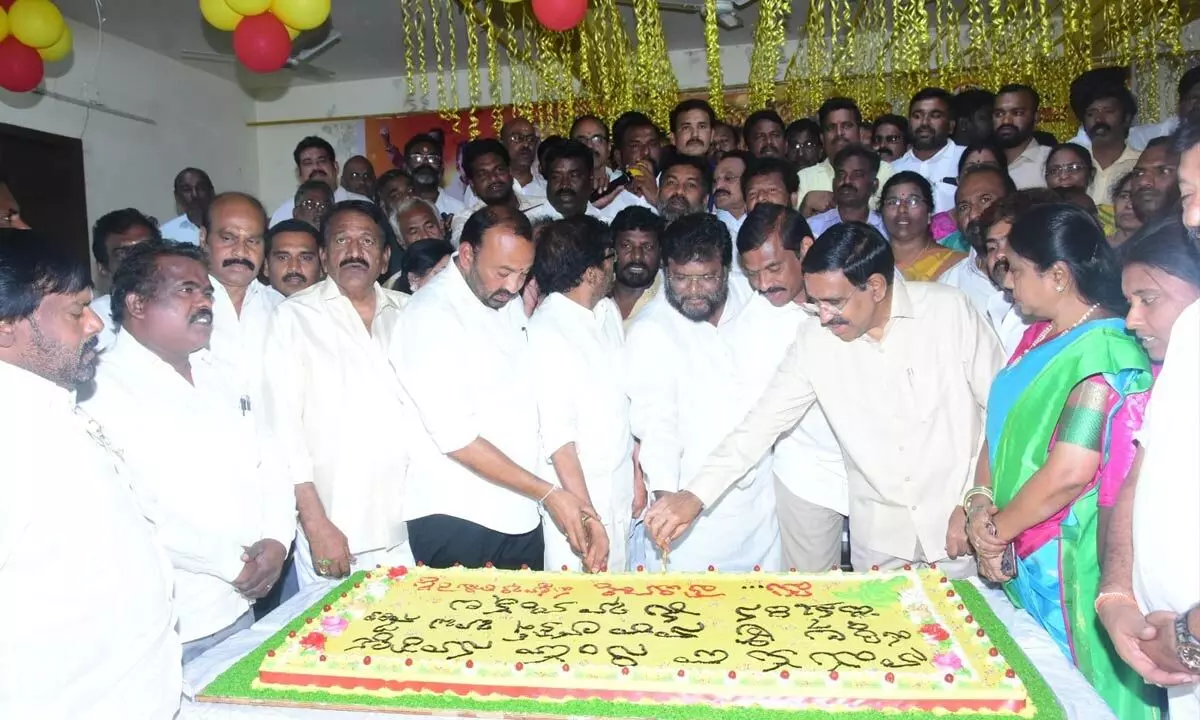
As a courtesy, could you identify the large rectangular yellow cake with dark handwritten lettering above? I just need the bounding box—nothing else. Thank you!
[256,568,1034,716]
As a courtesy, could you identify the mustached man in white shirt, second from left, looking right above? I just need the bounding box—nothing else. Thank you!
[82,242,295,664]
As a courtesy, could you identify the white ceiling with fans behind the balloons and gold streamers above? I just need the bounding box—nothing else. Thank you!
[55,0,757,88]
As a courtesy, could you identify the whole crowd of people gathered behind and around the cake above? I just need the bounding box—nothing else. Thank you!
[0,64,1200,720]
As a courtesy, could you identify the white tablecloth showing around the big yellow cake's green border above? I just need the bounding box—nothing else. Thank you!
[179,581,1116,720]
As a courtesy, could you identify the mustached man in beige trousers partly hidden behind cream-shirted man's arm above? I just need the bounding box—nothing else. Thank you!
[737,203,850,572]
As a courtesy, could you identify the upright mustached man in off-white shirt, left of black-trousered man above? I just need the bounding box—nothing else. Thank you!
[263,202,412,587]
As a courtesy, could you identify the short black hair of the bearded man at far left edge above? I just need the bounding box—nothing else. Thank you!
[0,228,91,322]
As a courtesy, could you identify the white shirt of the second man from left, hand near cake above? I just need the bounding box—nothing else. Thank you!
[82,332,295,642]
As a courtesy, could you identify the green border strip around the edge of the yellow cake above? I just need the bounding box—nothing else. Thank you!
[198,570,1066,720]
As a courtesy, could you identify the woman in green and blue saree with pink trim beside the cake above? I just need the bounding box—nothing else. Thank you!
[964,204,1158,720]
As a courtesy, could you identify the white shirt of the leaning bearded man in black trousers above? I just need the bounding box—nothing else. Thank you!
[389,254,546,535]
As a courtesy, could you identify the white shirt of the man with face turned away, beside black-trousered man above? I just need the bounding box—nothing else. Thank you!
[529,293,634,571]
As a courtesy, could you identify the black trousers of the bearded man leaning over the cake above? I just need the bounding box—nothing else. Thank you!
[408,515,546,570]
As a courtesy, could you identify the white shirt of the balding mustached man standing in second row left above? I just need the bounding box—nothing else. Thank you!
[209,276,282,409]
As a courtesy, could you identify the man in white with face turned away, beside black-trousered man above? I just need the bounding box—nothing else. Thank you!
[529,217,646,572]
